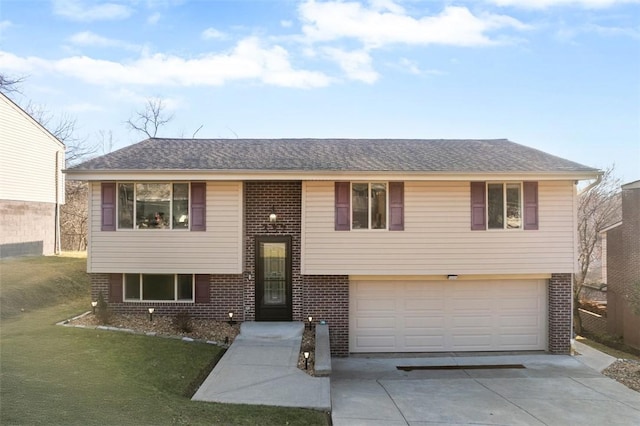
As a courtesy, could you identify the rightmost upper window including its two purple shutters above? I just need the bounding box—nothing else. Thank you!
[471,182,538,231]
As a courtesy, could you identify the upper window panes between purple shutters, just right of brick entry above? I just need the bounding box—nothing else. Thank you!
[351,183,387,229]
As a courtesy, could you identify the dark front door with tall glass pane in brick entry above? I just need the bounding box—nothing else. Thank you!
[256,237,291,321]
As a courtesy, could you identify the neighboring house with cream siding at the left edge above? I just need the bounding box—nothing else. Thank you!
[0,93,65,258]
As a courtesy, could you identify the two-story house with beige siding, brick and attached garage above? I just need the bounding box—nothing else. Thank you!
[67,139,600,356]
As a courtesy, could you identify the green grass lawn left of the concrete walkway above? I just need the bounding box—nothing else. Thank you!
[0,258,328,425]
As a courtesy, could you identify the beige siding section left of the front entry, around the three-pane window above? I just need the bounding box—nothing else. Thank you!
[87,182,242,274]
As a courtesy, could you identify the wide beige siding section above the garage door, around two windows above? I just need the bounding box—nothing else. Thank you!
[302,181,575,275]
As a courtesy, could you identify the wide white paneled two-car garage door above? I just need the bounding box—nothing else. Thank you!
[349,280,547,352]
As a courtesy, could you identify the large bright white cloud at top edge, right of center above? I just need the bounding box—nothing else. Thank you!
[299,0,529,47]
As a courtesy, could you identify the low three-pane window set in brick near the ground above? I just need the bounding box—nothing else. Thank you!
[124,274,194,302]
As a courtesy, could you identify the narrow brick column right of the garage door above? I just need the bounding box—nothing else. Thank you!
[548,274,573,354]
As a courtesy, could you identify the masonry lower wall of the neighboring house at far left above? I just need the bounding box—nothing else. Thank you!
[0,200,56,258]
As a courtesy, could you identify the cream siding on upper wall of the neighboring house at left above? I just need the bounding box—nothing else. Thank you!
[0,96,64,203]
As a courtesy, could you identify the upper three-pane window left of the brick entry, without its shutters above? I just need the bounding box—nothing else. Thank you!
[118,183,189,229]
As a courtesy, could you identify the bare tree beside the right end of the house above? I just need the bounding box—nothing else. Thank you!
[573,166,620,334]
